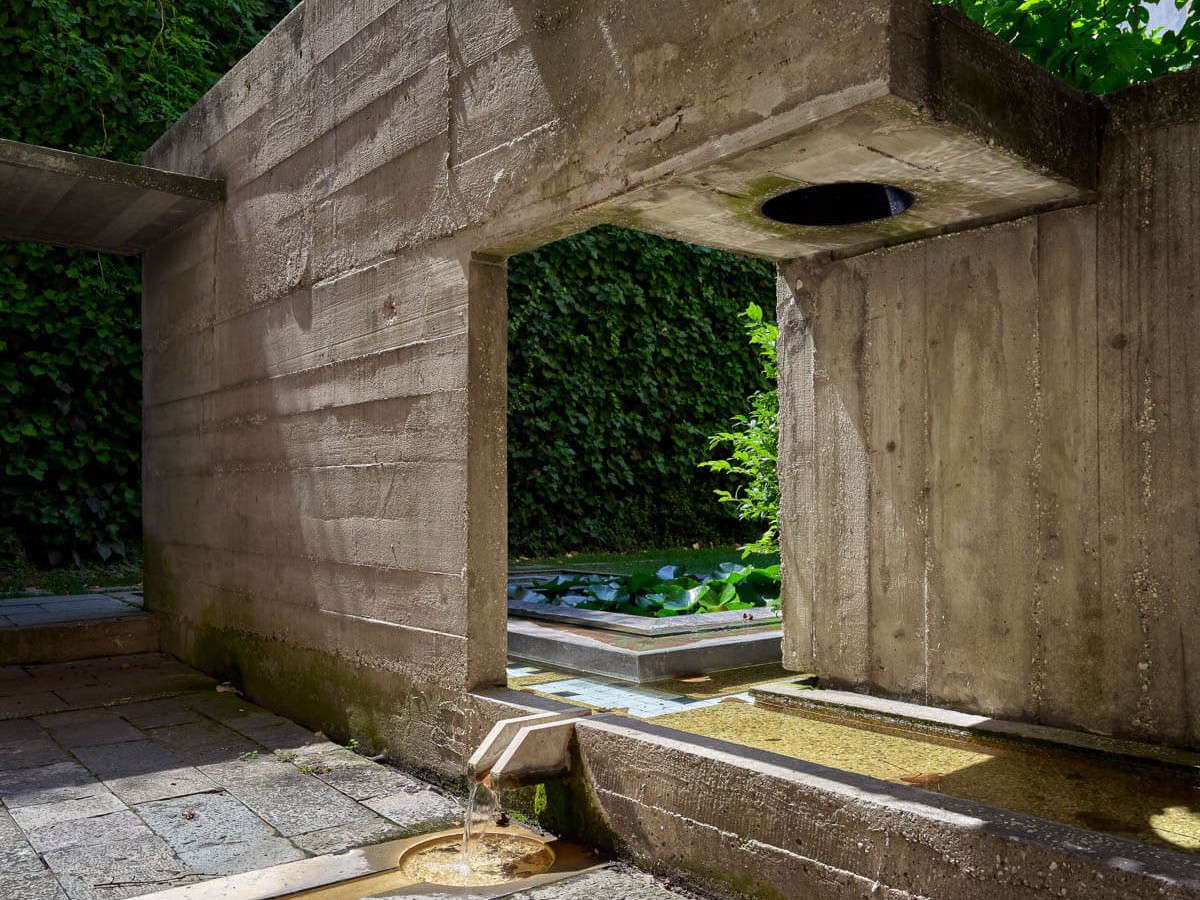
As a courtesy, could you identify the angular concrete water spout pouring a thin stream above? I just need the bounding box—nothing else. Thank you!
[467,709,592,791]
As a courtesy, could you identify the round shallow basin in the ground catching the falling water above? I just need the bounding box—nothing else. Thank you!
[398,834,554,887]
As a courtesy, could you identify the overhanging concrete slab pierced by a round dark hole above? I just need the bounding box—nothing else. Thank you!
[589,7,1102,259]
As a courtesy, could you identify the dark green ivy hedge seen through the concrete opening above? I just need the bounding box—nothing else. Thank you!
[509,227,775,554]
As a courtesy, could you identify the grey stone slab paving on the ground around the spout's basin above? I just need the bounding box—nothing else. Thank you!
[0,653,700,900]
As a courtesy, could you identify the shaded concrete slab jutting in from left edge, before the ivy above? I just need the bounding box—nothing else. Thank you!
[0,140,224,254]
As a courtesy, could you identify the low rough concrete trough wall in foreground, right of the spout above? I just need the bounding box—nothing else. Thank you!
[576,715,1200,900]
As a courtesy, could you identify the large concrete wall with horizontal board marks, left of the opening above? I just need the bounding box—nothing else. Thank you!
[144,0,923,773]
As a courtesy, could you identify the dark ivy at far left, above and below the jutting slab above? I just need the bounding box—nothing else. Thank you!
[0,0,295,562]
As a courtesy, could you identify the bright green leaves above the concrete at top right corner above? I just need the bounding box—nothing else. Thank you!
[944,0,1200,94]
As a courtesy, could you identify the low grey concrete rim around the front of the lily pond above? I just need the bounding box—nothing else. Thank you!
[509,619,782,684]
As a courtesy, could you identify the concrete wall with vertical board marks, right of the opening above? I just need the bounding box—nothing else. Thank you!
[780,71,1200,746]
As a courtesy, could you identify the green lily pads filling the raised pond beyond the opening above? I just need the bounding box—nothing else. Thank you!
[509,563,780,617]
